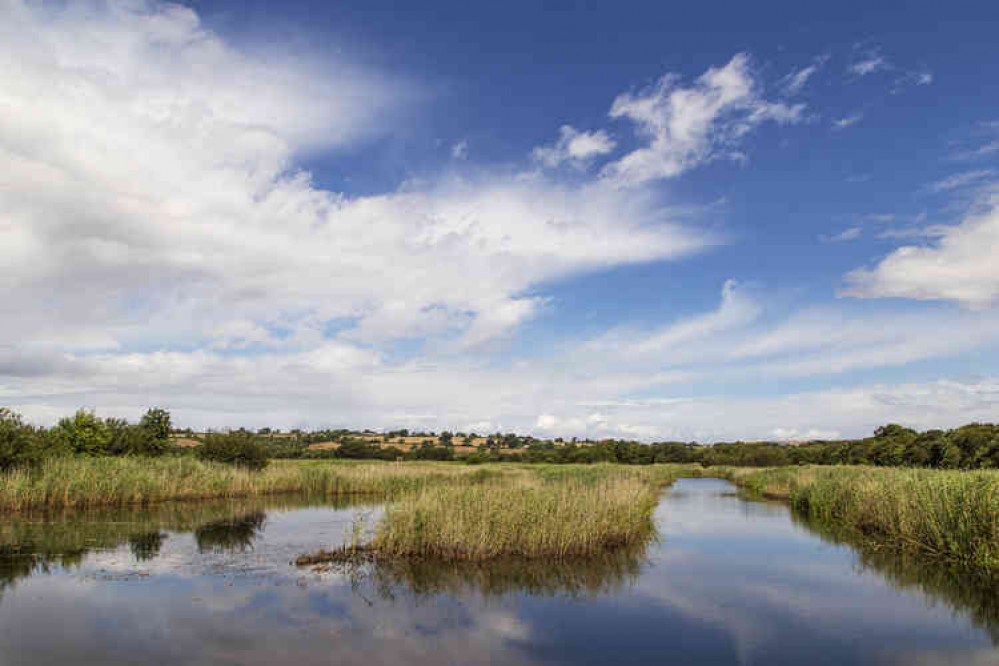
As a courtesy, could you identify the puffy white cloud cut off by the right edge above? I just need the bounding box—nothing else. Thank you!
[845,201,999,308]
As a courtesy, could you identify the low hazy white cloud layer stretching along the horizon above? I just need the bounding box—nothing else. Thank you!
[0,283,999,440]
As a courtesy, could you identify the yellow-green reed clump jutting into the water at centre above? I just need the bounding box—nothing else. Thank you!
[369,476,658,561]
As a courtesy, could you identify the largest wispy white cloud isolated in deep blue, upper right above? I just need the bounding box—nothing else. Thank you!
[603,53,805,187]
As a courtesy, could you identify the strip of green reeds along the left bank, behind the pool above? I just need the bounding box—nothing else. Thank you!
[0,457,513,512]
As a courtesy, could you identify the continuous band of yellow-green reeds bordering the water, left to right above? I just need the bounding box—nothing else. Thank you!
[7,456,999,571]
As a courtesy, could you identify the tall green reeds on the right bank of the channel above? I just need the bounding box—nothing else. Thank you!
[717,467,999,570]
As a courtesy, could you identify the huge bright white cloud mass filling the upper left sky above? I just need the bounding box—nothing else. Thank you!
[0,2,707,358]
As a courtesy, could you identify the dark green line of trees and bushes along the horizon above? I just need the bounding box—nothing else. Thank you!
[0,407,999,471]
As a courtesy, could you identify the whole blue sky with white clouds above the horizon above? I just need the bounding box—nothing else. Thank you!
[0,0,999,441]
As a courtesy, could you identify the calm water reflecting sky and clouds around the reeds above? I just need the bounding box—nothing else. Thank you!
[0,479,999,666]
